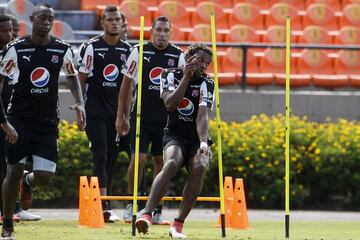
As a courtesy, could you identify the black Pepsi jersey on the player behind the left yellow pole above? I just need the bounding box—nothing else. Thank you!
[121,42,185,126]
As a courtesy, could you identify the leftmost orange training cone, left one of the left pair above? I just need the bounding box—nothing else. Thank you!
[79,176,90,226]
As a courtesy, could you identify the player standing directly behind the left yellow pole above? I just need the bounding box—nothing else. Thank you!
[116,16,185,225]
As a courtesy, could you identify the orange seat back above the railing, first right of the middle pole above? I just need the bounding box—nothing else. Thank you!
[225,24,261,42]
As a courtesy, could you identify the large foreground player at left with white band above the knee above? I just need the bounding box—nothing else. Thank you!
[0,4,85,239]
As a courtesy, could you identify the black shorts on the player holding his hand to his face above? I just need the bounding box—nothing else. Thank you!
[163,134,200,165]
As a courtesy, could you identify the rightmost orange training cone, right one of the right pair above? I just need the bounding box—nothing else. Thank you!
[231,178,249,229]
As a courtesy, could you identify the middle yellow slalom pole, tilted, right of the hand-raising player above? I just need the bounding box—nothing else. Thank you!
[210,13,226,238]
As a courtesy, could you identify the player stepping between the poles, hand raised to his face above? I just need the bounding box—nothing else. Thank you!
[136,44,214,238]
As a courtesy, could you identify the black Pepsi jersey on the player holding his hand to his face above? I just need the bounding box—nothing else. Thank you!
[160,68,214,141]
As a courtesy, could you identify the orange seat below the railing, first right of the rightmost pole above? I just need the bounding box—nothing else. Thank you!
[297,49,349,88]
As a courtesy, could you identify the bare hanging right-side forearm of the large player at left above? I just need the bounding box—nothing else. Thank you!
[66,75,86,130]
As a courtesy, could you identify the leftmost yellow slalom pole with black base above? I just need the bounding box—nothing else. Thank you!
[132,16,144,236]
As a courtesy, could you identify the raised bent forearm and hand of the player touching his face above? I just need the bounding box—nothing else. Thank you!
[161,55,197,112]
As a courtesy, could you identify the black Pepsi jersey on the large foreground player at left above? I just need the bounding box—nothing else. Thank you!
[0,36,76,125]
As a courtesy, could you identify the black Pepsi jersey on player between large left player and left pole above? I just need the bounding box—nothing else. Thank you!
[78,36,131,117]
